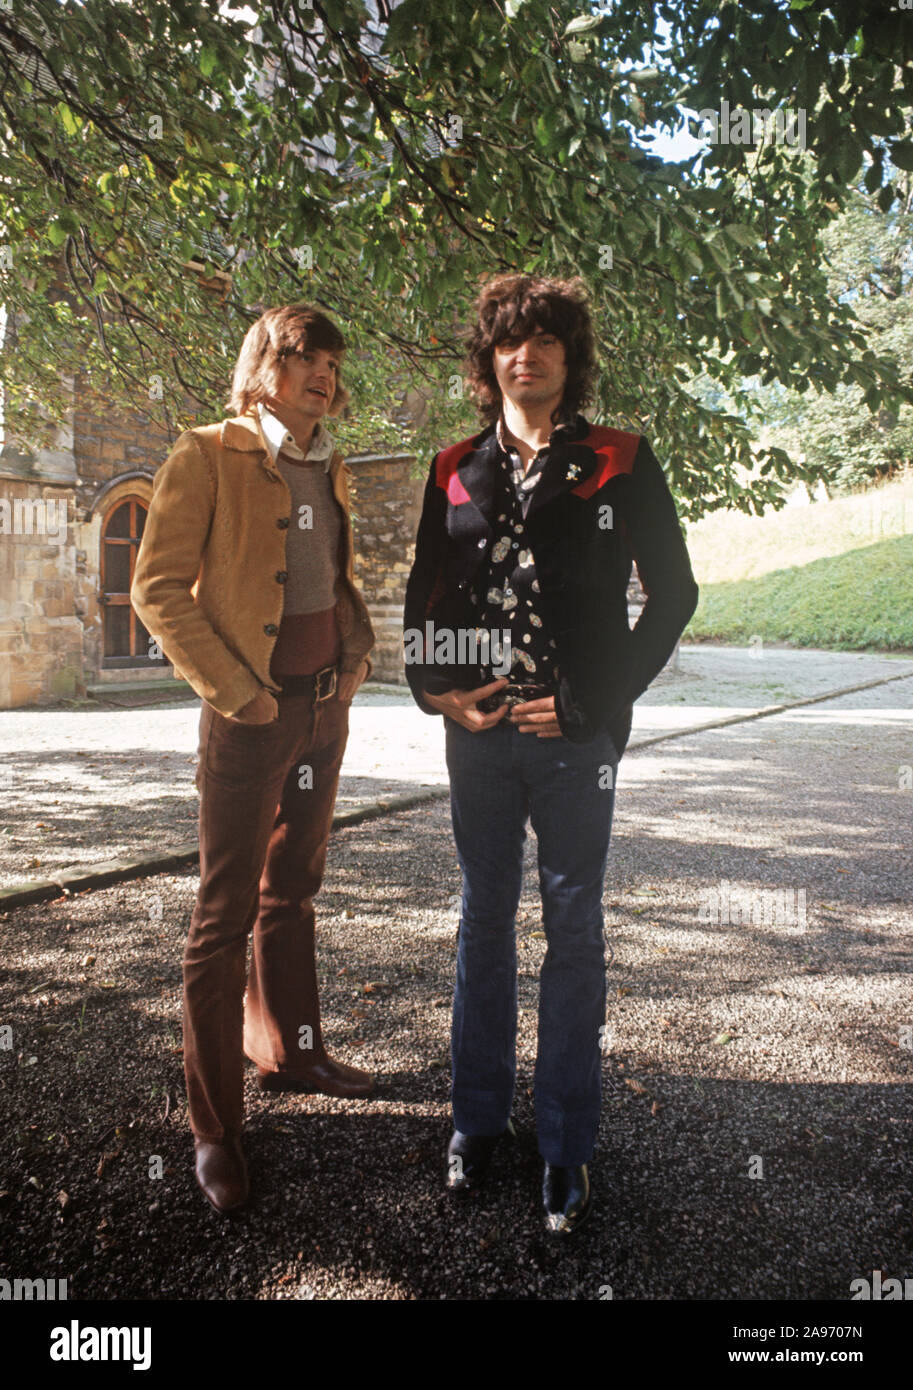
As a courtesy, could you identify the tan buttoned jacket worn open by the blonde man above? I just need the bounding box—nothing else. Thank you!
[131,413,374,716]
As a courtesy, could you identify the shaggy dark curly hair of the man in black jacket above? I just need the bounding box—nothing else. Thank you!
[466,275,596,425]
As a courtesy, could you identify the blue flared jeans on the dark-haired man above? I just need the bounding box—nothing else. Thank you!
[445,719,618,1165]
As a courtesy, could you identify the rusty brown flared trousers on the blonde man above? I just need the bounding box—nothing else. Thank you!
[183,695,349,1143]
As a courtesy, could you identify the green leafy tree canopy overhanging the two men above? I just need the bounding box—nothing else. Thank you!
[0,0,913,517]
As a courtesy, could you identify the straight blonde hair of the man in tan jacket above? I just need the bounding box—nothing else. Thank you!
[228,304,350,416]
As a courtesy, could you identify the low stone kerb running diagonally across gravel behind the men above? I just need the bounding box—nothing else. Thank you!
[0,671,913,913]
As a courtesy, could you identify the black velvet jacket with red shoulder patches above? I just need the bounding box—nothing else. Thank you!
[404,416,698,756]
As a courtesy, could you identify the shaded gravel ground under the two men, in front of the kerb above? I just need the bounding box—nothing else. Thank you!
[0,672,913,1301]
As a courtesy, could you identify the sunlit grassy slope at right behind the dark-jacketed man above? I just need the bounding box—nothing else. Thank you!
[684,478,913,651]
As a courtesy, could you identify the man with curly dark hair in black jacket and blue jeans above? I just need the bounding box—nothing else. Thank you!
[404,275,698,1234]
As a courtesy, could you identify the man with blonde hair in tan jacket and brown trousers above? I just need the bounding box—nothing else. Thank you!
[131,304,374,1212]
